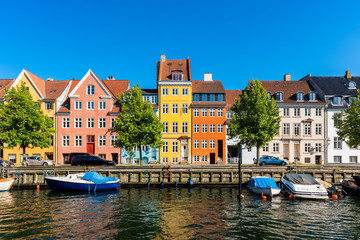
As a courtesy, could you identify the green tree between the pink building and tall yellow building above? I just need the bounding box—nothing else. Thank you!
[112,85,163,164]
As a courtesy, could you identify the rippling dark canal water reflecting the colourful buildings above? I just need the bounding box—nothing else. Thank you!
[0,187,360,239]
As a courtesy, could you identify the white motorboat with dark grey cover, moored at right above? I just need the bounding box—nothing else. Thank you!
[281,173,329,199]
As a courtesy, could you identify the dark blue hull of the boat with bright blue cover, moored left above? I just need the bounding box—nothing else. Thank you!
[45,177,120,192]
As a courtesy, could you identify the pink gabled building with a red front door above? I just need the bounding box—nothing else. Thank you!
[57,70,130,164]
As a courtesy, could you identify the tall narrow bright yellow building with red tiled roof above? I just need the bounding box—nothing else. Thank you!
[157,55,192,164]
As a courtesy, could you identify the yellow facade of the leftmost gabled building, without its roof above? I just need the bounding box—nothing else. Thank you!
[3,70,57,165]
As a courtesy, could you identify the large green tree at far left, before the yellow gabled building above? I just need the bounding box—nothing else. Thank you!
[0,83,55,161]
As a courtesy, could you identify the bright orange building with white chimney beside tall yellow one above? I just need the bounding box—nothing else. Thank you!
[192,73,226,164]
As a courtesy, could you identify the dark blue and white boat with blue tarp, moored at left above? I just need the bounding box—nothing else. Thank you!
[45,172,120,192]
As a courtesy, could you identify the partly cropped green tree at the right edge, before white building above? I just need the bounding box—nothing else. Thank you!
[333,89,360,148]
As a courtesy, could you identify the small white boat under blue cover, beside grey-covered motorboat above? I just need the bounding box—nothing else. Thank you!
[248,176,281,197]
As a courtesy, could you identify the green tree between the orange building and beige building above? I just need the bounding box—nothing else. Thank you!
[229,80,281,165]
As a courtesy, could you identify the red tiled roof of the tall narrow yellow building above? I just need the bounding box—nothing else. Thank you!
[157,55,191,81]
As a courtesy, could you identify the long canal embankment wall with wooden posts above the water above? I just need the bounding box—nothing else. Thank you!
[1,165,360,188]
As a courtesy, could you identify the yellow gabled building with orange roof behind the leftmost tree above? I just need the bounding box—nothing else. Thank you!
[2,69,70,165]
